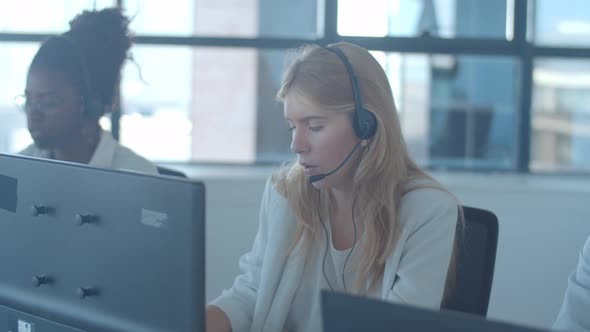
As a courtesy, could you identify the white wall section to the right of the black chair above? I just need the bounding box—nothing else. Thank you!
[440,175,590,327]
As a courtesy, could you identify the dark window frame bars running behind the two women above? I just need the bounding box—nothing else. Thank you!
[0,0,590,174]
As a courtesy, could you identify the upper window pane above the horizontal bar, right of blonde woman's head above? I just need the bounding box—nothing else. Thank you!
[338,0,514,39]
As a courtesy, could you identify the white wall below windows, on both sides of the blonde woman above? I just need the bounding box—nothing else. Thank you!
[175,167,590,327]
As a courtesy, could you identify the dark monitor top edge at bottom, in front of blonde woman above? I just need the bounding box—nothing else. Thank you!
[321,292,542,332]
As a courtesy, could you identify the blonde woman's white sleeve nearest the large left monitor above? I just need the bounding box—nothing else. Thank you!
[210,179,273,332]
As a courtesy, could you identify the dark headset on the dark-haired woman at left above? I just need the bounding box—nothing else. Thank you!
[55,34,105,118]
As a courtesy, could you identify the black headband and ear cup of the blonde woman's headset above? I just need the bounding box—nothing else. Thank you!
[324,46,377,140]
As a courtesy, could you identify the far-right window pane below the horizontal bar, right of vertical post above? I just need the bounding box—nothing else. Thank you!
[531,58,590,171]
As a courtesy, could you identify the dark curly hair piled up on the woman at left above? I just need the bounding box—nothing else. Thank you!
[29,8,132,118]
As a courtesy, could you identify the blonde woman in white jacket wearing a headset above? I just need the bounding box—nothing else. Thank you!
[207,43,459,332]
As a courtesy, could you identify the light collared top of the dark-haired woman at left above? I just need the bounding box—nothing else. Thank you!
[19,130,158,174]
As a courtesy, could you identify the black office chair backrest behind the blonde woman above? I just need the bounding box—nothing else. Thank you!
[441,206,498,317]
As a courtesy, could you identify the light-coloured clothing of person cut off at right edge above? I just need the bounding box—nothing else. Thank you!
[553,236,590,331]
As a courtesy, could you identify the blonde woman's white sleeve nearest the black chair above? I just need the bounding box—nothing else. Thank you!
[384,189,458,309]
